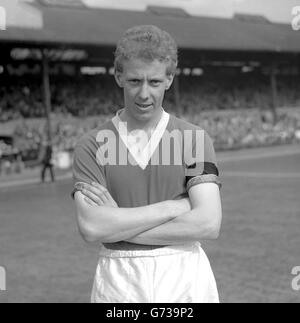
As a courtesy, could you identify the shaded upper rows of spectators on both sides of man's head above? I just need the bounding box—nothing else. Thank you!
[0,73,300,122]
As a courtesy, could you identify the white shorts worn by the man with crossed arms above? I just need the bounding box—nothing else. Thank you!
[91,242,219,303]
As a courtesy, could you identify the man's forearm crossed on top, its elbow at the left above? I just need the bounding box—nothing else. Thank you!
[76,193,187,243]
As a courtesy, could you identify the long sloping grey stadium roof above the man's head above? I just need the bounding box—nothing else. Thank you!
[0,3,300,53]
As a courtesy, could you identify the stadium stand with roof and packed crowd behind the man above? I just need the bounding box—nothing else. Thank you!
[0,0,300,177]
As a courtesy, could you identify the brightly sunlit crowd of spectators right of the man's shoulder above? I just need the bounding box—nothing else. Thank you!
[182,109,300,150]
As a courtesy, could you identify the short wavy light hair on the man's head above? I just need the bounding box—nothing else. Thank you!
[114,25,178,75]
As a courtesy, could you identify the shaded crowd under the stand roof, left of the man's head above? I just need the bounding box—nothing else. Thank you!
[0,76,122,122]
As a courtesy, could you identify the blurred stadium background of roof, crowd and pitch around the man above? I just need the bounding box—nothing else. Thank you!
[0,0,300,302]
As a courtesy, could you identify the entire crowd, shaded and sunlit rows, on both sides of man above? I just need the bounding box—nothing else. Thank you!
[0,75,300,175]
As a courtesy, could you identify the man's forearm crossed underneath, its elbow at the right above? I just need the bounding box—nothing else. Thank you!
[126,209,221,245]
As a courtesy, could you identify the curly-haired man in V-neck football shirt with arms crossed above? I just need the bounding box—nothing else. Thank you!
[73,26,222,303]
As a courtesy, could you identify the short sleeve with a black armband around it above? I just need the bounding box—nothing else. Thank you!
[185,129,222,191]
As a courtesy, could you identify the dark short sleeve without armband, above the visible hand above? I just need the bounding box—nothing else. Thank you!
[71,141,107,198]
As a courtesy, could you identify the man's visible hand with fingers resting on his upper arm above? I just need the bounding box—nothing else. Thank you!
[75,182,118,207]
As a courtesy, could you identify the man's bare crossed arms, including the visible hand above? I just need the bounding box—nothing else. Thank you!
[75,183,222,245]
